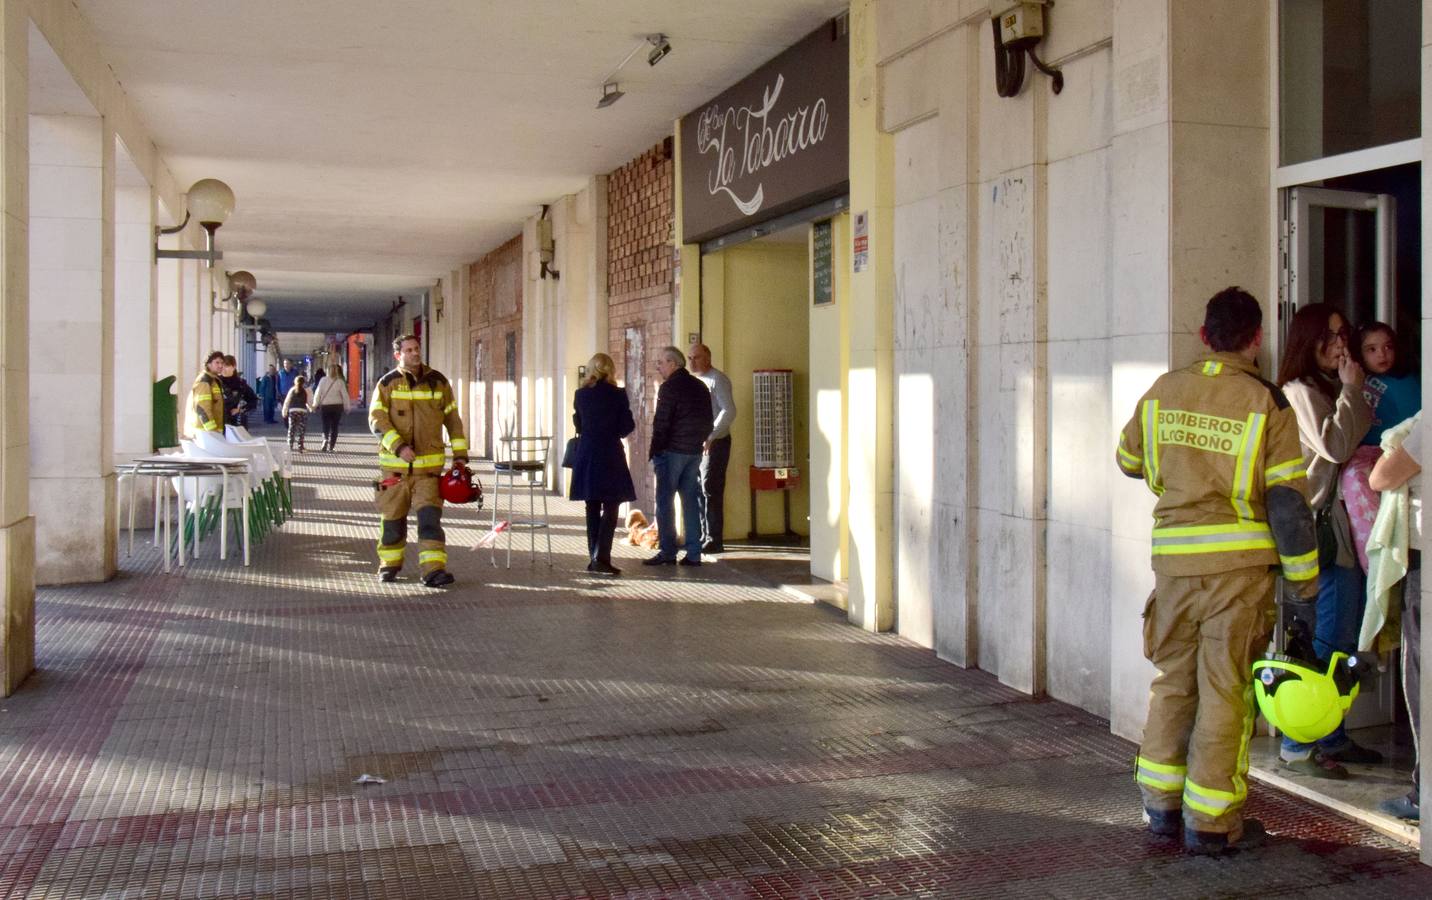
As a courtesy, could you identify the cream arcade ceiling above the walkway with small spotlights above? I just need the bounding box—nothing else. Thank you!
[67,0,848,330]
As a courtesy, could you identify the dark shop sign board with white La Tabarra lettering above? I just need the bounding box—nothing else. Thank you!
[679,23,851,244]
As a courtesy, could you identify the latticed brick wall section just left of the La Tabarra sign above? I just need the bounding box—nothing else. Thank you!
[607,139,676,516]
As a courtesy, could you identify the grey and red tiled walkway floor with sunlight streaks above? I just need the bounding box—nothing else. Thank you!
[8,421,1432,900]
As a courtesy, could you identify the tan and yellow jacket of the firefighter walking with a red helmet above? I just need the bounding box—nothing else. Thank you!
[368,365,467,474]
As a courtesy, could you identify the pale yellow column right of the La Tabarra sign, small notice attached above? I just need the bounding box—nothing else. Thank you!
[846,0,895,631]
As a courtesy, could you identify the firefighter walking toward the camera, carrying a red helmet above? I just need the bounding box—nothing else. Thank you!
[368,334,467,588]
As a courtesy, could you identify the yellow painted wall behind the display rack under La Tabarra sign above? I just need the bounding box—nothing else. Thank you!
[702,242,811,539]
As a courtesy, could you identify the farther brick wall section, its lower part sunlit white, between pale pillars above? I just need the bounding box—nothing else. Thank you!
[467,235,523,457]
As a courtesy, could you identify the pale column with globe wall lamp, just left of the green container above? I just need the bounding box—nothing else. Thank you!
[113,175,158,461]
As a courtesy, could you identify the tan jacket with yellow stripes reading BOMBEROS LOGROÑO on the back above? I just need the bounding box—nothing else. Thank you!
[1117,353,1317,582]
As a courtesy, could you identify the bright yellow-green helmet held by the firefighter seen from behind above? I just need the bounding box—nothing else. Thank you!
[1253,654,1358,744]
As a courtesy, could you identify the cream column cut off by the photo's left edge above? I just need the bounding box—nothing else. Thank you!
[0,0,34,696]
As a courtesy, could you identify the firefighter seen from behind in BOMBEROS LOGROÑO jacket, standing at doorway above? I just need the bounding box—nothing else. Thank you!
[1117,288,1317,853]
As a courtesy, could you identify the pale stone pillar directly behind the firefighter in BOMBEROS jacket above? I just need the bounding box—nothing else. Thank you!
[1108,0,1272,739]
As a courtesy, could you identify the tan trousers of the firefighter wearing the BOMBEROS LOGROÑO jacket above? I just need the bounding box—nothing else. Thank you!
[1134,566,1276,840]
